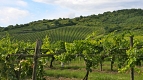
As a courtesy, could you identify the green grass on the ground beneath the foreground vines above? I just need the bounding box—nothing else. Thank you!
[45,60,143,80]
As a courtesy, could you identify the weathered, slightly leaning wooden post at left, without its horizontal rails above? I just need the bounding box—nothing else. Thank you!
[32,40,42,80]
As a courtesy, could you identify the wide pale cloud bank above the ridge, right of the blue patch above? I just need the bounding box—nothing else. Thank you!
[33,0,143,21]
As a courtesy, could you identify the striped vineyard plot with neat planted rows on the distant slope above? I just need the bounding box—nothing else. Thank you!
[9,26,95,42]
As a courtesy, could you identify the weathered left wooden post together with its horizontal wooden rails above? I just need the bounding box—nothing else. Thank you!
[9,40,53,80]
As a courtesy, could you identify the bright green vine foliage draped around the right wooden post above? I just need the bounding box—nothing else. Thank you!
[120,39,143,73]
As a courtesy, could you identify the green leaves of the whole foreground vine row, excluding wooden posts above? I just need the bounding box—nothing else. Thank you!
[0,31,143,79]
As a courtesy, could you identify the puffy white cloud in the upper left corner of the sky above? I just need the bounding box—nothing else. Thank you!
[0,0,30,26]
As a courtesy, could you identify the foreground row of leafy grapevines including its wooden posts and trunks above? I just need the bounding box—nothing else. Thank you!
[0,28,143,80]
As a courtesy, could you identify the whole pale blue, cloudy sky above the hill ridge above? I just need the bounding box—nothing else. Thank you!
[0,0,143,27]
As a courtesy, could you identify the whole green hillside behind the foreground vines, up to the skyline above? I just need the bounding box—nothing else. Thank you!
[0,9,143,42]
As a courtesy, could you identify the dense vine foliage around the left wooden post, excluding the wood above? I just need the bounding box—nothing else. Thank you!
[0,35,44,80]
